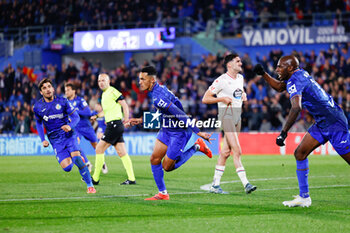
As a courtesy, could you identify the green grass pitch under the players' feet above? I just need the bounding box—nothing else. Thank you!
[0,155,350,233]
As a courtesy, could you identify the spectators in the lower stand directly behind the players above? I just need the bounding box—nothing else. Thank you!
[0,43,350,134]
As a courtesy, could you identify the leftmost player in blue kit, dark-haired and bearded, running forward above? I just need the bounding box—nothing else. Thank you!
[33,78,96,193]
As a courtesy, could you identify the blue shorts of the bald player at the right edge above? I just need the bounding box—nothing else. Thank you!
[308,121,350,155]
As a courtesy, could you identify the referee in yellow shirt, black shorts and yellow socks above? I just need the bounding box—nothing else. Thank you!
[91,74,136,185]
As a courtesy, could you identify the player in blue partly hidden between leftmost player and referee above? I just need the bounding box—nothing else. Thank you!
[65,83,107,174]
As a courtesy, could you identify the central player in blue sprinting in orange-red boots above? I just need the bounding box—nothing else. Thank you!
[127,66,212,201]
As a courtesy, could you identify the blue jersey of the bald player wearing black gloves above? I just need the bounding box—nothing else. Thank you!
[285,69,347,128]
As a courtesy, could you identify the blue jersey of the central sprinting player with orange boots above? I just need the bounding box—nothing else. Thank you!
[151,82,199,133]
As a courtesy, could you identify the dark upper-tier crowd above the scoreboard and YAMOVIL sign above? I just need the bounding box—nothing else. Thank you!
[0,0,350,33]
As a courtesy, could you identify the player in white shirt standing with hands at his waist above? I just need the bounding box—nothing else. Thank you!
[202,53,256,194]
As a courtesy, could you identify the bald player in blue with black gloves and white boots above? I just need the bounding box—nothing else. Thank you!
[254,56,350,207]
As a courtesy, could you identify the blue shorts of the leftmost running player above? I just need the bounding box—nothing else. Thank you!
[50,133,80,163]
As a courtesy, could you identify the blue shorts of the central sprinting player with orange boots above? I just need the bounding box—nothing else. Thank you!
[157,128,192,160]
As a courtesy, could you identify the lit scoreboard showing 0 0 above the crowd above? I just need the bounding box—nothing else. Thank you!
[73,27,175,53]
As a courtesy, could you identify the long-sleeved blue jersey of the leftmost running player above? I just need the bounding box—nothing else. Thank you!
[33,96,75,141]
